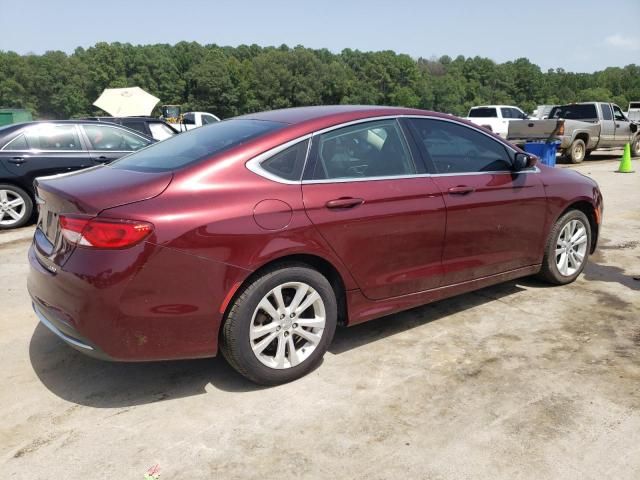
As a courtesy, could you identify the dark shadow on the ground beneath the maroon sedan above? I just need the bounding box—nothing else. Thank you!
[29,282,522,408]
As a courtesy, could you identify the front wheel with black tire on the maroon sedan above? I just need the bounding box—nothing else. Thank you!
[539,210,591,285]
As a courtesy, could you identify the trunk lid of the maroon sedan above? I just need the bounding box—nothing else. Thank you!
[34,166,173,266]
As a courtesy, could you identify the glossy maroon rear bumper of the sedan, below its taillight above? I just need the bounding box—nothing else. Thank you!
[27,244,249,361]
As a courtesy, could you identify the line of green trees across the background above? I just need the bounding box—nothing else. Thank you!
[0,42,640,119]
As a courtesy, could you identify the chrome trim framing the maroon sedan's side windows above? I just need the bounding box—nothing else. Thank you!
[245,114,528,185]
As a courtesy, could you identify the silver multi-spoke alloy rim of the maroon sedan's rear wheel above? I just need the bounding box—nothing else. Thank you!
[249,282,326,369]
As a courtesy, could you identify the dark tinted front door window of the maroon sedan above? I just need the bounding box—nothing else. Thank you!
[410,118,511,174]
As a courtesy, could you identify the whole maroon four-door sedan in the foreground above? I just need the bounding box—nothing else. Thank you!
[28,106,602,384]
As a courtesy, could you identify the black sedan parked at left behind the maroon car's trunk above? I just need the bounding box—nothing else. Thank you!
[0,120,155,230]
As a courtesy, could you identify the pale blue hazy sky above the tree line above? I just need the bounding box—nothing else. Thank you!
[0,0,640,72]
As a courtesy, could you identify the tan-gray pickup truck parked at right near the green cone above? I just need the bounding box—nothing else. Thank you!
[507,102,640,163]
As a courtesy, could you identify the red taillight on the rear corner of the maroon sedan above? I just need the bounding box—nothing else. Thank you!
[60,215,153,248]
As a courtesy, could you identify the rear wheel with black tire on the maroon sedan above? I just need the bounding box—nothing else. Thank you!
[220,264,338,385]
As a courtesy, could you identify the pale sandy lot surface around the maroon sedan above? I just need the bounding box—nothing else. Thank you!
[0,155,640,480]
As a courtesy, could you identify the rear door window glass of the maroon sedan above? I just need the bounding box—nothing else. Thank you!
[313,120,416,180]
